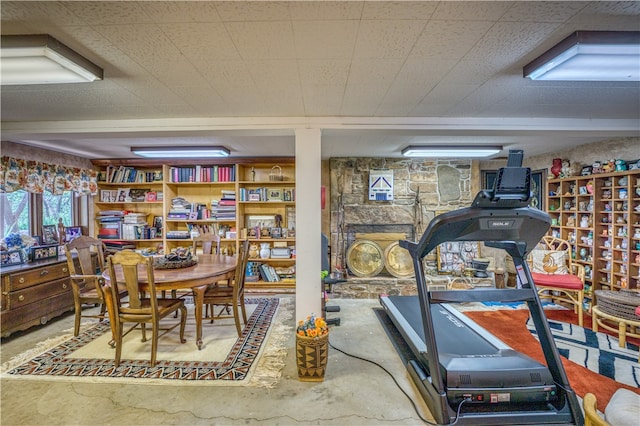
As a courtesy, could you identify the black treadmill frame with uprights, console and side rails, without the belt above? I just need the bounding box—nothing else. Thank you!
[390,198,584,425]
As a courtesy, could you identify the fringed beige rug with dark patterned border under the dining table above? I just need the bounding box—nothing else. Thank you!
[1,298,293,387]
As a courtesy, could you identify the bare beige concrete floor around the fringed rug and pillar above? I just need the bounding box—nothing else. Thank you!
[0,295,432,426]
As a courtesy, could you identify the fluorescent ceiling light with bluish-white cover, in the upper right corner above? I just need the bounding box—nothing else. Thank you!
[523,31,640,81]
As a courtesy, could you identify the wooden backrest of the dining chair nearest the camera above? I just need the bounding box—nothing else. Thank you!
[107,250,158,316]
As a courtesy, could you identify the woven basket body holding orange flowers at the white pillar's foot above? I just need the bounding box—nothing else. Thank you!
[296,333,329,382]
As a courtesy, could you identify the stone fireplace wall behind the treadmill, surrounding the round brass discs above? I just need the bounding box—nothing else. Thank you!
[330,158,480,298]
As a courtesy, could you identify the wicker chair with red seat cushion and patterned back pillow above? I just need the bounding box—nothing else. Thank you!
[529,236,584,326]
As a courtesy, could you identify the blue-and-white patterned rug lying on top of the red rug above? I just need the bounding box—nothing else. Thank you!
[527,320,640,388]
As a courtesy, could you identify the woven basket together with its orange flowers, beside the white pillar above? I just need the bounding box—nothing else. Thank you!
[296,315,329,382]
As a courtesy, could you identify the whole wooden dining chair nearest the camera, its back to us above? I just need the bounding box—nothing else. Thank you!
[107,250,187,367]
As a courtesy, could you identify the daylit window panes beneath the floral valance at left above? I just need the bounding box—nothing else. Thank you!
[0,190,77,238]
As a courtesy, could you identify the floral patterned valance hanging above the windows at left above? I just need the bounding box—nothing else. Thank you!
[0,156,98,195]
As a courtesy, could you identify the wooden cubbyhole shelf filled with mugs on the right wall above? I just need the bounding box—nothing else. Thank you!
[547,166,640,300]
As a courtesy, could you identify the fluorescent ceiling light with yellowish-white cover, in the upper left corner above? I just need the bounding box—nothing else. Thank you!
[0,35,103,85]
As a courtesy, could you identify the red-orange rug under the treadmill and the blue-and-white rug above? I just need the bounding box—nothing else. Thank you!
[465,309,640,411]
